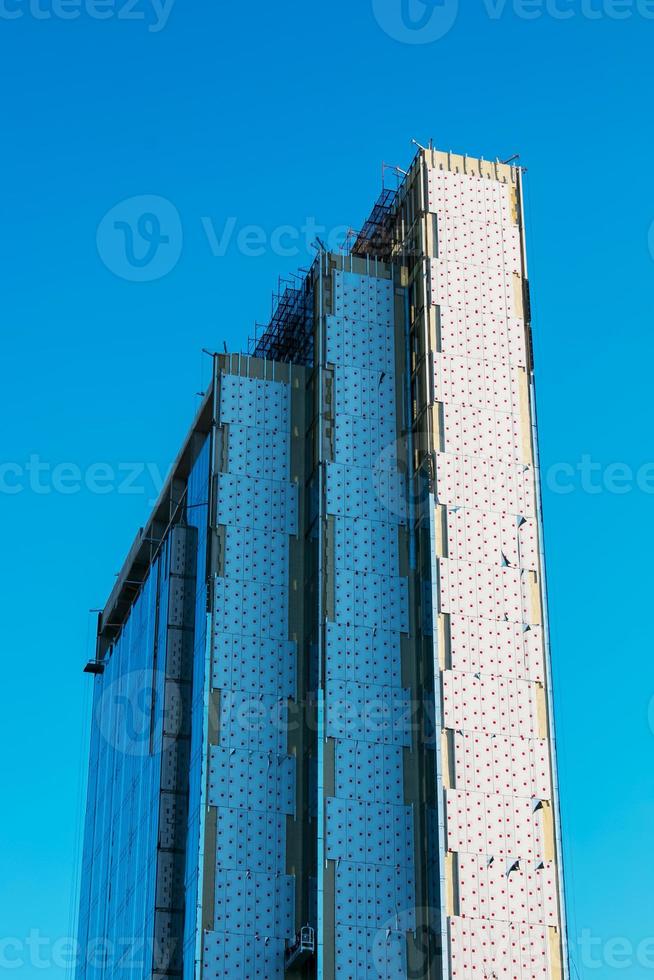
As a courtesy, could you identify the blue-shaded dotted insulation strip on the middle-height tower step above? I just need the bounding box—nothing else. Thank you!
[325,272,415,980]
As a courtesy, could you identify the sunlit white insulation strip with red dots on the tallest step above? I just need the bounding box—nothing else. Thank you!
[427,170,559,980]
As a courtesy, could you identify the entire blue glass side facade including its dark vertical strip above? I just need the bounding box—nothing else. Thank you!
[78,439,209,980]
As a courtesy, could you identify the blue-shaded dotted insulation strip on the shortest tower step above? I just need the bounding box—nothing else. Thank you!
[203,374,298,980]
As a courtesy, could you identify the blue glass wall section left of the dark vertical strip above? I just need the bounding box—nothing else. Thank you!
[78,545,170,980]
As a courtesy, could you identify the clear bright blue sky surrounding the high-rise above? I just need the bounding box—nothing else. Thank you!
[0,0,654,980]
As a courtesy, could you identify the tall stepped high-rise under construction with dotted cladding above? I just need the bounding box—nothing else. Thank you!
[78,148,567,980]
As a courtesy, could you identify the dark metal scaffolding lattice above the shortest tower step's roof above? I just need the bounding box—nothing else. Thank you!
[249,270,314,366]
